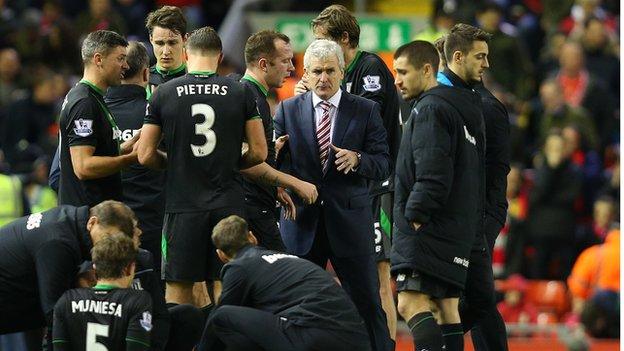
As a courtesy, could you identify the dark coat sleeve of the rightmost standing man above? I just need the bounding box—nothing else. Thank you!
[483,101,510,234]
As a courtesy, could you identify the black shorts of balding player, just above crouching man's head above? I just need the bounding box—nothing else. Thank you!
[245,206,286,252]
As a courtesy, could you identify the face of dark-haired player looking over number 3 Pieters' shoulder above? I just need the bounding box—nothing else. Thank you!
[150,27,185,70]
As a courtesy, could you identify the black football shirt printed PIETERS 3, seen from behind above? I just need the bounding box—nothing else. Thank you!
[145,72,260,213]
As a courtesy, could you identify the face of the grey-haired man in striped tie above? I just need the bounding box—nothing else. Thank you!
[305,55,344,100]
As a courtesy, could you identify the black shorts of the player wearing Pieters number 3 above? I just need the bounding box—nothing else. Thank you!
[161,207,243,282]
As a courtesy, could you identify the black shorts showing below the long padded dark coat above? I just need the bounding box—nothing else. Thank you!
[396,269,461,299]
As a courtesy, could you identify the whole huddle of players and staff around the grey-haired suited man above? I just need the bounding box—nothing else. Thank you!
[0,5,509,351]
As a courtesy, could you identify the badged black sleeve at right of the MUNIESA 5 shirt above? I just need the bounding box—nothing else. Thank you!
[126,291,152,351]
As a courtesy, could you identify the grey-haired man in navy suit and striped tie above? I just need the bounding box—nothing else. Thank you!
[275,39,394,351]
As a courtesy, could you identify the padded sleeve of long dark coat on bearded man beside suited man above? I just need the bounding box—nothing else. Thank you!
[405,106,455,224]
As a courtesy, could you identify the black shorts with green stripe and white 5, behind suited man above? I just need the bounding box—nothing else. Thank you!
[373,193,394,262]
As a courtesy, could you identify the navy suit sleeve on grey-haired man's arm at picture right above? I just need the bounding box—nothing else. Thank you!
[356,103,390,180]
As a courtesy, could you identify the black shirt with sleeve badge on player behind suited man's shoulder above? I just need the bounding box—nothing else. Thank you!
[342,51,401,195]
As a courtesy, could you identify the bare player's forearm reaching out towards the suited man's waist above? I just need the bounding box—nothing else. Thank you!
[241,162,318,203]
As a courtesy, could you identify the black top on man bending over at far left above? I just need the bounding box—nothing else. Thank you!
[0,206,93,317]
